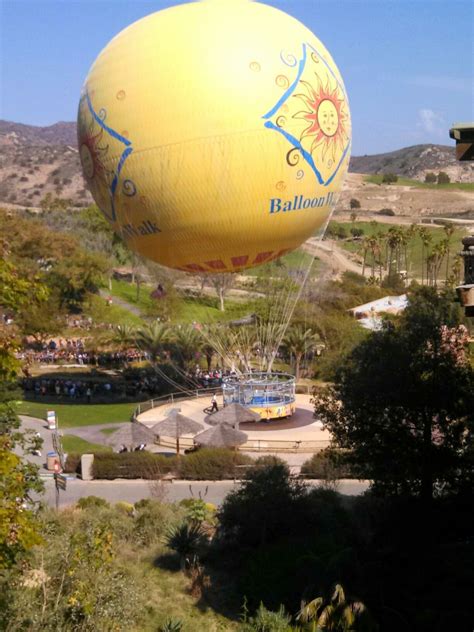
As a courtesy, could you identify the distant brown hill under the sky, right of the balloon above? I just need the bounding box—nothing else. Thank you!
[349,145,474,182]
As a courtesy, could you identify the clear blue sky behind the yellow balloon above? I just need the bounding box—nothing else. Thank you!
[0,0,474,155]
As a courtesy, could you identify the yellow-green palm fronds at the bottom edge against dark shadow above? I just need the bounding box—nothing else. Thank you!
[297,584,378,632]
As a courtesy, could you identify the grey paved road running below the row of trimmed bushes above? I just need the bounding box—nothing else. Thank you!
[37,478,368,507]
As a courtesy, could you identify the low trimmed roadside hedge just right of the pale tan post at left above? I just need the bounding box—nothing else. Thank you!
[92,452,176,480]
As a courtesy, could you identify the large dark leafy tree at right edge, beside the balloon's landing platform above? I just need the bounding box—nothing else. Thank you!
[314,287,474,500]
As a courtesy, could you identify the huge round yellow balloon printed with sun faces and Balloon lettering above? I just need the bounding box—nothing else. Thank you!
[78,0,351,272]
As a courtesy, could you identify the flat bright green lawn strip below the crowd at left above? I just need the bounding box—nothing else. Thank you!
[18,401,138,428]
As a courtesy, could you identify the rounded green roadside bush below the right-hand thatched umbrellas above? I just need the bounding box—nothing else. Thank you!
[179,448,253,480]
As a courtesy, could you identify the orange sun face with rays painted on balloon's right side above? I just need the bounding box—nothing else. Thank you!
[293,73,348,166]
